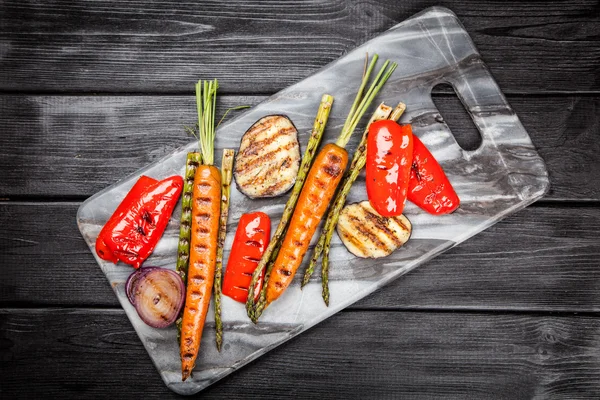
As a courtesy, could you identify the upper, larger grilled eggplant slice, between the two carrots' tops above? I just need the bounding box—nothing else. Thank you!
[233,115,300,199]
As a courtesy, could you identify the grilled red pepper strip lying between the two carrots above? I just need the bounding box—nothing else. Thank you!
[222,212,271,303]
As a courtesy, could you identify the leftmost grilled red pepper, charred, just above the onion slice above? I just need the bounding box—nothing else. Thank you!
[96,176,183,268]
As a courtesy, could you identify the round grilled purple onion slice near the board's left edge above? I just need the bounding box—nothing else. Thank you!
[127,267,185,328]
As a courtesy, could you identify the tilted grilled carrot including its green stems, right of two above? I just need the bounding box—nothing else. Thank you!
[255,55,396,310]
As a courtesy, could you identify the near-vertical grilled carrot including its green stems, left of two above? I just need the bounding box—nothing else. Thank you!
[180,80,221,381]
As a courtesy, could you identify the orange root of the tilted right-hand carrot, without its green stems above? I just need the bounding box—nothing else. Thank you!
[267,143,348,304]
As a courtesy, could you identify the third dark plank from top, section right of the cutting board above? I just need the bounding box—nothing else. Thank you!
[355,207,600,312]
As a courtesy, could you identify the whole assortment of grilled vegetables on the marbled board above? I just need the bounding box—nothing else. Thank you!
[96,55,459,380]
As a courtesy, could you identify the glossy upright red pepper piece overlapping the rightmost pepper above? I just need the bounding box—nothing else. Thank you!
[366,120,413,217]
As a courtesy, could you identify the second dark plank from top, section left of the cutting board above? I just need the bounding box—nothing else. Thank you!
[0,96,265,197]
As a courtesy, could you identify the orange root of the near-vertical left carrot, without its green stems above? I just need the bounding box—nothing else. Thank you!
[180,165,221,380]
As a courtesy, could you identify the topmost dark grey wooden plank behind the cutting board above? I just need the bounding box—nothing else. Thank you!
[0,0,600,93]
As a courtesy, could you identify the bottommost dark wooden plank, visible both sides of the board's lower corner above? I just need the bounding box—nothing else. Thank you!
[0,309,600,399]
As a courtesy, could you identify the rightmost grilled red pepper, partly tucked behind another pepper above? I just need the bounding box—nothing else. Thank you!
[408,136,460,215]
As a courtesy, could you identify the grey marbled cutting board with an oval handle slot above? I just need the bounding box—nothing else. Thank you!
[77,7,549,394]
